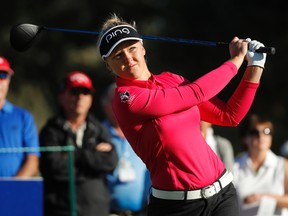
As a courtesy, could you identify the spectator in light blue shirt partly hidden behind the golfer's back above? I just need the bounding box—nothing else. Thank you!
[101,83,151,216]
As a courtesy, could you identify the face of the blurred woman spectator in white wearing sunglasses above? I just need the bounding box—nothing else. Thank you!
[244,124,272,151]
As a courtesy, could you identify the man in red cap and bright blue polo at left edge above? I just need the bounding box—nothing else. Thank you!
[0,57,40,178]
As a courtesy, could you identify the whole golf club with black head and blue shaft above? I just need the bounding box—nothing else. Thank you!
[10,23,276,55]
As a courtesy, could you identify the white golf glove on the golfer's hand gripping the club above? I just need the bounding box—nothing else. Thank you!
[246,38,267,68]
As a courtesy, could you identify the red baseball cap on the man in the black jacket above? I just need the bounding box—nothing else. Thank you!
[60,71,95,92]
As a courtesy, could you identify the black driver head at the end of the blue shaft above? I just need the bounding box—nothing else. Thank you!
[10,24,43,52]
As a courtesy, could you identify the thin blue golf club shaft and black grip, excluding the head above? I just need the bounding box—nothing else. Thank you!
[43,27,276,55]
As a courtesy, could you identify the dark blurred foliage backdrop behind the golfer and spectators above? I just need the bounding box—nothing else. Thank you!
[0,0,288,153]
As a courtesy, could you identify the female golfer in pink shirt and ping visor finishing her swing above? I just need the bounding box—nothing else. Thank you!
[98,14,266,216]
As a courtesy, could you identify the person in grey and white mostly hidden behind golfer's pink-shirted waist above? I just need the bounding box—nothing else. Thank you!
[200,121,234,171]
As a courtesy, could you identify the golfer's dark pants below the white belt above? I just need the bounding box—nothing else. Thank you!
[147,183,239,216]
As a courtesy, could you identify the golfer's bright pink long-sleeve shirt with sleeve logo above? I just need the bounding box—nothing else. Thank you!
[112,62,259,190]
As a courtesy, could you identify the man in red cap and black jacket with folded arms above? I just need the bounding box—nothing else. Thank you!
[40,71,118,216]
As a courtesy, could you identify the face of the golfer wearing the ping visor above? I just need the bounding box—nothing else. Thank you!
[106,41,150,80]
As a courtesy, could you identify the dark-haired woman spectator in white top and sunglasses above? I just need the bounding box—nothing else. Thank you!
[233,114,288,216]
